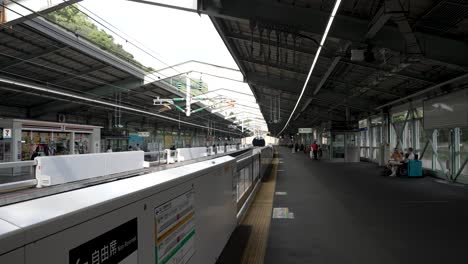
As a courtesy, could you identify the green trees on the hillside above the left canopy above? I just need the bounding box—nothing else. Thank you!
[47,5,154,72]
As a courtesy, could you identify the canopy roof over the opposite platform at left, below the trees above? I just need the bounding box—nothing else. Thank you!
[0,17,240,133]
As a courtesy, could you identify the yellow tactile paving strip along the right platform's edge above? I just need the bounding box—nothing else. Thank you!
[241,158,278,264]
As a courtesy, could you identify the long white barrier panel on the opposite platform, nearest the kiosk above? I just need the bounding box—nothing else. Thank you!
[36,151,144,187]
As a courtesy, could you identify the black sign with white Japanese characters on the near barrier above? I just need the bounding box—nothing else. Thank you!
[68,218,138,264]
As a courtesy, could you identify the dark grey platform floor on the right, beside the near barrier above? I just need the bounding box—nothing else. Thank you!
[219,148,468,264]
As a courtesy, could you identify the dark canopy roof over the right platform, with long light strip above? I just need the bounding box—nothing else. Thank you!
[193,0,468,133]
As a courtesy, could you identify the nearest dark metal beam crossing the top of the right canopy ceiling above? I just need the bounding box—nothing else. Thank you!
[203,0,468,65]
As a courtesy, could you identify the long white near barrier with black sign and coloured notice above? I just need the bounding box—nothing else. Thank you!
[0,157,237,264]
